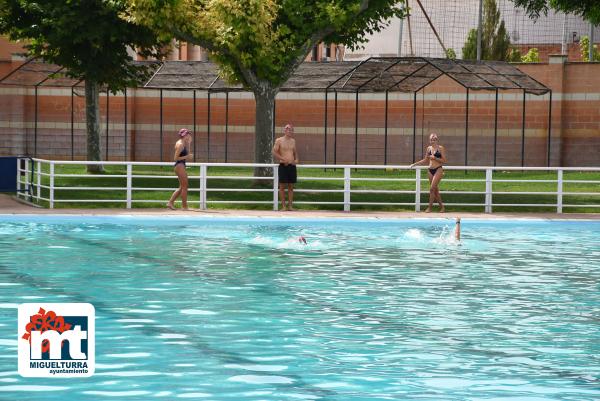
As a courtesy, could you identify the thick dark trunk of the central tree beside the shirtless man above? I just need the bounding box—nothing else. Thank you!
[254,83,277,181]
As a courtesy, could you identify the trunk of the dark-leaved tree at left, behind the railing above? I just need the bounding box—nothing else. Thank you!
[85,79,104,173]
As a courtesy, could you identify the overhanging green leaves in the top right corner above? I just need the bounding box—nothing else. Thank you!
[512,0,600,25]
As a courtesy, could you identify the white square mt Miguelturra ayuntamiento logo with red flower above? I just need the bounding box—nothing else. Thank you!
[18,303,95,377]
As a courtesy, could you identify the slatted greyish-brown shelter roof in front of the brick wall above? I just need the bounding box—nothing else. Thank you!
[0,57,550,95]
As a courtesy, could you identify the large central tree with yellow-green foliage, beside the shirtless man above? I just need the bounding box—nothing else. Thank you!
[129,0,406,176]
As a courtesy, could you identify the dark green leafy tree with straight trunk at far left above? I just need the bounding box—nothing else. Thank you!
[0,0,162,172]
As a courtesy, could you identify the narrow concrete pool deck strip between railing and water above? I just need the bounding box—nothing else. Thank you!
[0,194,600,220]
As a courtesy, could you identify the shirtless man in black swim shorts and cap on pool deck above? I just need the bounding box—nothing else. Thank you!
[273,124,298,210]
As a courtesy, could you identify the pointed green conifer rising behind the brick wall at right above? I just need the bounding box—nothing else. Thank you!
[463,0,511,61]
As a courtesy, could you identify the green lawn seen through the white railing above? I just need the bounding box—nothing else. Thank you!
[19,165,600,213]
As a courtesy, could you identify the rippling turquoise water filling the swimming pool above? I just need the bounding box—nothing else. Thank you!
[0,216,600,401]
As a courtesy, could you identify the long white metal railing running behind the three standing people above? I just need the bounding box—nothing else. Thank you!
[17,158,600,213]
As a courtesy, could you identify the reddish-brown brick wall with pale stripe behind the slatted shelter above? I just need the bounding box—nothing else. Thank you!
[0,60,600,166]
